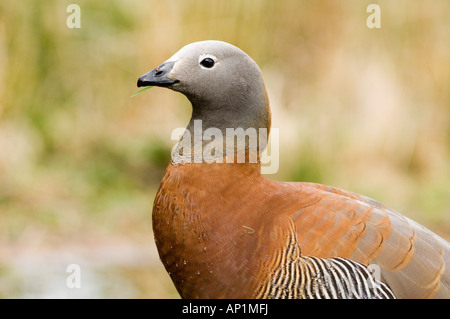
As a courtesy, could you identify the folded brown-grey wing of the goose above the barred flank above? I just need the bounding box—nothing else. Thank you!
[292,183,450,298]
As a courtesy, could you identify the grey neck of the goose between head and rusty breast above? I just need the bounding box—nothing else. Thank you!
[172,98,270,164]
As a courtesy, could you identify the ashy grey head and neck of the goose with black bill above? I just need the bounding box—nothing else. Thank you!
[138,40,270,164]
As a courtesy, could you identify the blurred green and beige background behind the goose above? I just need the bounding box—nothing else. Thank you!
[0,0,450,298]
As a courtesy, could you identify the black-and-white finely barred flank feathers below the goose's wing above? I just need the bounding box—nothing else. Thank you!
[256,222,395,299]
